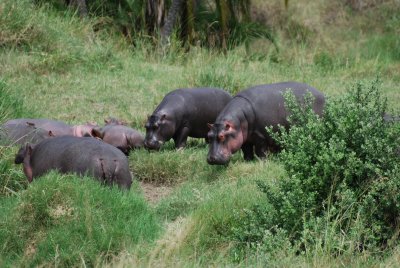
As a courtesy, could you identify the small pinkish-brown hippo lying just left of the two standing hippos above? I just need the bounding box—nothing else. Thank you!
[91,123,144,155]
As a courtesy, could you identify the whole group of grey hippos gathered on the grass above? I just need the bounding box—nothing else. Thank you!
[0,82,325,189]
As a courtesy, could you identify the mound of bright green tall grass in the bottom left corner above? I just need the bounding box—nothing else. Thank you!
[0,172,159,267]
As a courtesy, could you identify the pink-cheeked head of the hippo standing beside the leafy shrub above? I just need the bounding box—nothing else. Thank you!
[207,120,244,165]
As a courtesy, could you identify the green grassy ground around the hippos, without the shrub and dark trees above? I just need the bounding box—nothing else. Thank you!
[0,0,400,267]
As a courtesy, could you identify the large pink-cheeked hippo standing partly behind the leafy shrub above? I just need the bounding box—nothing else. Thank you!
[207,82,325,165]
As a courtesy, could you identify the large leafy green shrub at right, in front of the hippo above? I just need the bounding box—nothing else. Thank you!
[231,81,400,256]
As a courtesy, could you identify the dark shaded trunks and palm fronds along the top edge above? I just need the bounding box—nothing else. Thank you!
[35,0,276,50]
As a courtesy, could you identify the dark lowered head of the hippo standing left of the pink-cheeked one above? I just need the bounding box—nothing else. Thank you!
[144,114,175,150]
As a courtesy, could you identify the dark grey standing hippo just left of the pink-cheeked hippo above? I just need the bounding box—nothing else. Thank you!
[144,88,232,150]
